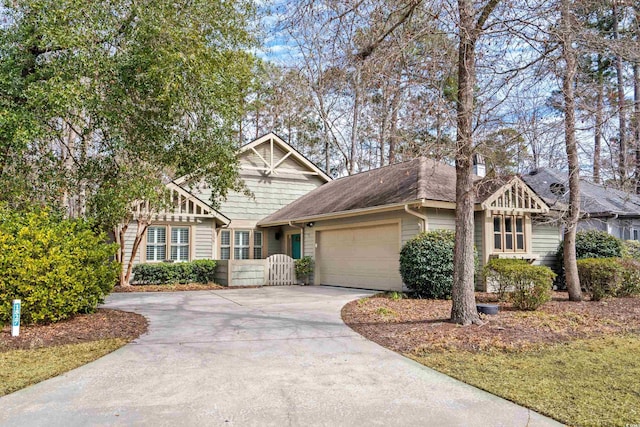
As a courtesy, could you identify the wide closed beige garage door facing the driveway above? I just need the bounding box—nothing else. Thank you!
[316,224,402,291]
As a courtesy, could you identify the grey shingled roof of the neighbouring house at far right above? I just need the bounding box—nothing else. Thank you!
[522,168,640,217]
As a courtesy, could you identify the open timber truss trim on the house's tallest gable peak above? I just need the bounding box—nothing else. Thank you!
[240,132,331,182]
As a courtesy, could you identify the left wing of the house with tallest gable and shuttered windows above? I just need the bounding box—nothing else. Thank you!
[120,133,331,285]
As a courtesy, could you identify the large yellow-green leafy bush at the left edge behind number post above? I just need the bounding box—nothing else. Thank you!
[0,208,120,324]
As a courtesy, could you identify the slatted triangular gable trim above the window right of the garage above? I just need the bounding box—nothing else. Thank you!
[480,176,549,213]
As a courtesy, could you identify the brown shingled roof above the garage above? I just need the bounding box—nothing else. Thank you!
[258,157,502,225]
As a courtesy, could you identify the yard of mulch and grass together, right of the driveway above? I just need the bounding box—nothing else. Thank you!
[342,293,640,426]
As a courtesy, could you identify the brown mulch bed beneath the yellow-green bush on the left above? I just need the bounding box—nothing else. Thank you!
[0,308,148,352]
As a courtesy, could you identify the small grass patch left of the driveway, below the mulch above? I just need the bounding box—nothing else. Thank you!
[0,338,128,396]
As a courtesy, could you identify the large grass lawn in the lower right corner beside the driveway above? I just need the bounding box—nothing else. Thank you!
[409,335,640,426]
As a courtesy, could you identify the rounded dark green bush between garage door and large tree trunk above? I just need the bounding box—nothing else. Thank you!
[400,230,455,299]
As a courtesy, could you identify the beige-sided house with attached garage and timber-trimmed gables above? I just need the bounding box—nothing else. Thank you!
[122,134,560,291]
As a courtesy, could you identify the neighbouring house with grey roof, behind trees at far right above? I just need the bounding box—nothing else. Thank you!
[522,168,640,240]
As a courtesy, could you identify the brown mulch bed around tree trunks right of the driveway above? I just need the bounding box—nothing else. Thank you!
[342,292,640,353]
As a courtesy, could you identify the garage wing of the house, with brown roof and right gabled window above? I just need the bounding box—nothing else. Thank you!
[258,158,560,291]
